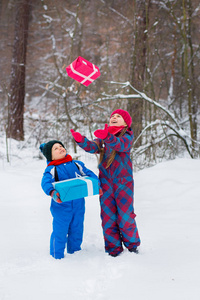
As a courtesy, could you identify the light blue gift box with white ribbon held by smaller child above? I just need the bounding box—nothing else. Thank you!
[53,176,99,202]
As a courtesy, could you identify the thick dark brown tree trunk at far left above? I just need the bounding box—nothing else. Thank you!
[7,0,31,141]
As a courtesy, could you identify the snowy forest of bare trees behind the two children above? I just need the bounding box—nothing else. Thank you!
[0,0,200,170]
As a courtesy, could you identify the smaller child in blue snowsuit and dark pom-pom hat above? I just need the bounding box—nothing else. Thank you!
[40,140,97,259]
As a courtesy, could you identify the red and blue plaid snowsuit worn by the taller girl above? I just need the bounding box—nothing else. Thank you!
[78,128,140,255]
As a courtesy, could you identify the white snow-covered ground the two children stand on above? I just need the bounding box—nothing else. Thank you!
[0,156,200,300]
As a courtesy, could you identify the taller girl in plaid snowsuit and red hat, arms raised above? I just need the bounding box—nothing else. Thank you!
[71,109,140,256]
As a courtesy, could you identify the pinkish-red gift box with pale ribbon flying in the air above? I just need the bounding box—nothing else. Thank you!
[66,56,101,86]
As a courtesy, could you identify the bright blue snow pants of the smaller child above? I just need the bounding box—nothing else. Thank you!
[50,198,85,259]
